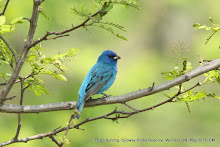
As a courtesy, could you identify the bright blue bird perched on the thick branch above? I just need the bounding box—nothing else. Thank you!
[75,50,121,119]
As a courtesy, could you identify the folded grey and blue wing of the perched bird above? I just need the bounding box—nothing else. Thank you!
[84,73,113,101]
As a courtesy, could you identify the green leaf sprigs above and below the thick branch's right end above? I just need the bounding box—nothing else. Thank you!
[161,41,220,112]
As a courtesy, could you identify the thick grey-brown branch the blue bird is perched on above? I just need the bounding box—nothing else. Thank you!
[0,59,220,113]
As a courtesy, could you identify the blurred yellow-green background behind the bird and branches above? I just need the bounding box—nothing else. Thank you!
[0,0,220,147]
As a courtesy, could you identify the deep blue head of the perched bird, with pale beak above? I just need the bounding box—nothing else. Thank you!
[97,50,121,65]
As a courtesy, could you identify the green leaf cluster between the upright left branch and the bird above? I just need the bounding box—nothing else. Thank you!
[24,45,77,96]
